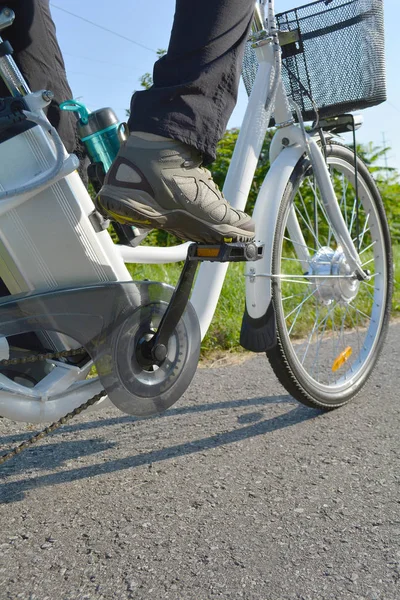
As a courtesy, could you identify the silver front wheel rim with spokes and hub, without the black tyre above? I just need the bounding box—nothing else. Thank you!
[273,156,387,403]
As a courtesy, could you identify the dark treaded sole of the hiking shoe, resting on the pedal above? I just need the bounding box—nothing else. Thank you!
[96,194,254,244]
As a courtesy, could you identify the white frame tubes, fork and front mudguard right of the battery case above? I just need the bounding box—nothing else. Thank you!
[120,0,365,338]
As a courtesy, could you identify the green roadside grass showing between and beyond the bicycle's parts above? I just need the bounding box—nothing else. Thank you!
[128,245,400,356]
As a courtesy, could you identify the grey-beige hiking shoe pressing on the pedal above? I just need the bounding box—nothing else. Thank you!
[96,133,254,244]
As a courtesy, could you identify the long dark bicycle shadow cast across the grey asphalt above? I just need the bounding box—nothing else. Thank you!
[0,396,323,504]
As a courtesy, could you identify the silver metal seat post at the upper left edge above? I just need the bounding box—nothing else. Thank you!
[0,8,31,97]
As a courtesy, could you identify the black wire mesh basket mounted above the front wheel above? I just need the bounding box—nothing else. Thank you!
[242,0,386,121]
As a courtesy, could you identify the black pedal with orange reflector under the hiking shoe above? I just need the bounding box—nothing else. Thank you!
[187,242,264,262]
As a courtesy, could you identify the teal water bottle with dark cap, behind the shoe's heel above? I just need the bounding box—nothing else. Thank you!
[60,100,128,173]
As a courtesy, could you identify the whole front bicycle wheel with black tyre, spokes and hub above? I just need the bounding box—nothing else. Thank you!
[267,143,393,409]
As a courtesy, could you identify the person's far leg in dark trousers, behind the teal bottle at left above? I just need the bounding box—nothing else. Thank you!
[0,0,83,172]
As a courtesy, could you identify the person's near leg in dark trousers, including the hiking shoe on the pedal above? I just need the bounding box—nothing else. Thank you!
[97,0,254,243]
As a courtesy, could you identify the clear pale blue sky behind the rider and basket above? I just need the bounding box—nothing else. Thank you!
[50,0,400,171]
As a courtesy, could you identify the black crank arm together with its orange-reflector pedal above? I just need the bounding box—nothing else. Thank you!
[139,242,264,364]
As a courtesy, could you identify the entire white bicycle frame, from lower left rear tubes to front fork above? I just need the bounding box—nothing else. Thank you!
[0,0,366,422]
